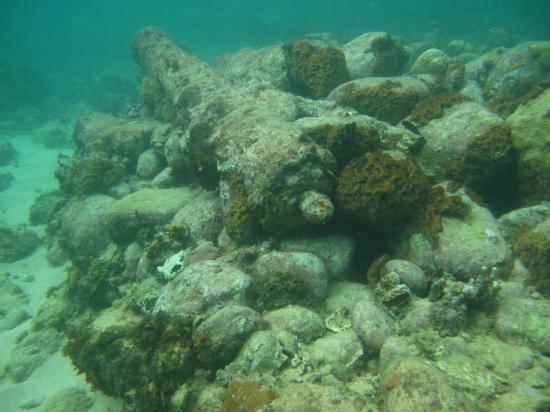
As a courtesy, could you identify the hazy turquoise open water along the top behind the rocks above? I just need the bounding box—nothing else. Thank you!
[0,0,550,70]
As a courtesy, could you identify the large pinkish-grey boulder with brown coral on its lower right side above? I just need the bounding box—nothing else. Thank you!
[417,102,511,179]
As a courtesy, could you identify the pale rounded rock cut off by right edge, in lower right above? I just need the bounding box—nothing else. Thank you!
[495,298,550,356]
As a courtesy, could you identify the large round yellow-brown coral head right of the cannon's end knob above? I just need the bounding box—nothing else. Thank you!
[336,152,430,231]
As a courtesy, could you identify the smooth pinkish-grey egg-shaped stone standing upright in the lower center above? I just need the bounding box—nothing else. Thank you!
[352,300,396,354]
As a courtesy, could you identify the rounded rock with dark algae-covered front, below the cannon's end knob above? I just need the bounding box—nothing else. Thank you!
[253,252,328,308]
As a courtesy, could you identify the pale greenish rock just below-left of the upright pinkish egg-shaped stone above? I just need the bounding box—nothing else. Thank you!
[310,330,363,382]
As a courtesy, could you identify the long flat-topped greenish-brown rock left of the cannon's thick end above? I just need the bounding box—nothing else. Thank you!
[107,188,197,243]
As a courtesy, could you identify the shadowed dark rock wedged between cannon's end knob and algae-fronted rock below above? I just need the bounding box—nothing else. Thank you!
[280,234,355,280]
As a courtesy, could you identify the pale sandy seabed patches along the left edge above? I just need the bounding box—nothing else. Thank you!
[0,122,122,412]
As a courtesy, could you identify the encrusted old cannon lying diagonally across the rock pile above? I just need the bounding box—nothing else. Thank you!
[132,27,335,241]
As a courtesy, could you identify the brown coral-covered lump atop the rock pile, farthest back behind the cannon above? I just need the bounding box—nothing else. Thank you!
[283,40,349,99]
